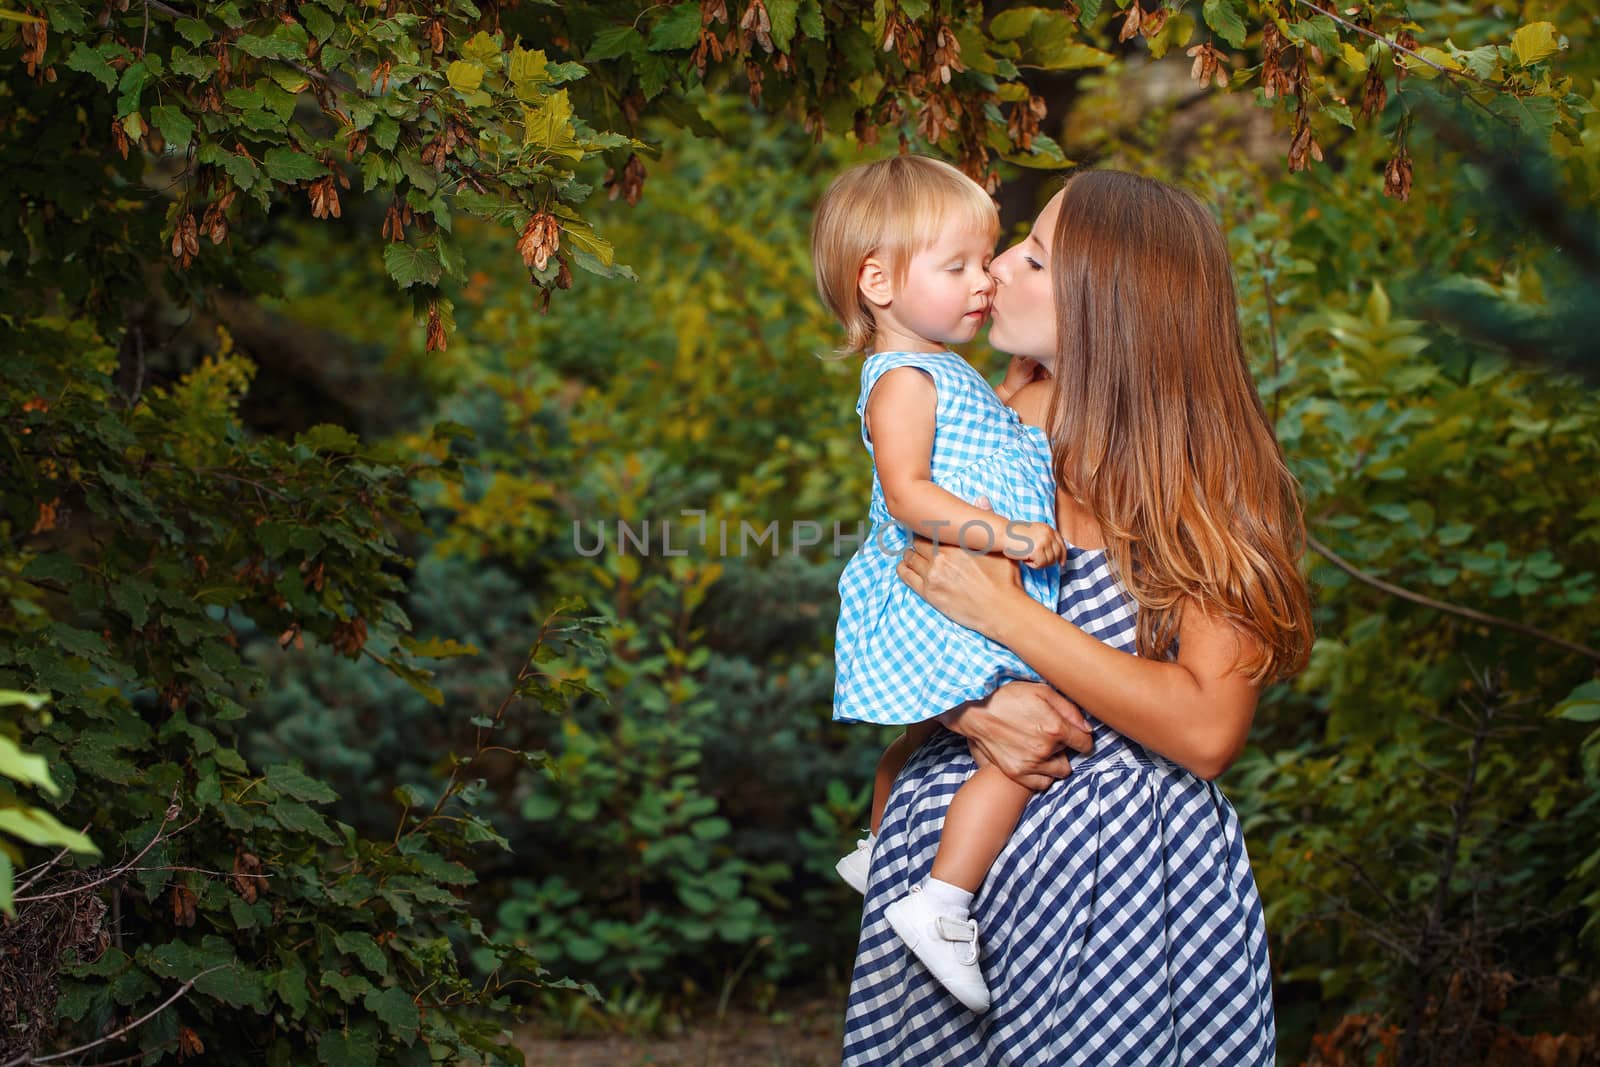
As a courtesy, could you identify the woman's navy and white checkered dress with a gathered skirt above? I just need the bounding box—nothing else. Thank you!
[843,549,1277,1067]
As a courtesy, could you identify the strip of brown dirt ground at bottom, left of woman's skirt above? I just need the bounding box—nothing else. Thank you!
[518,1000,843,1067]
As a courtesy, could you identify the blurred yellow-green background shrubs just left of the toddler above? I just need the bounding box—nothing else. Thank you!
[235,109,883,1009]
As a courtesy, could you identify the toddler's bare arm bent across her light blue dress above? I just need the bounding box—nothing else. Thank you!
[867,366,1064,566]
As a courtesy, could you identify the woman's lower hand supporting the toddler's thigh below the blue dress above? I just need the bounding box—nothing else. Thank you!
[939,681,1093,792]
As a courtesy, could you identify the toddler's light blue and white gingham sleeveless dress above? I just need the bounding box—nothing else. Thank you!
[834,352,1061,725]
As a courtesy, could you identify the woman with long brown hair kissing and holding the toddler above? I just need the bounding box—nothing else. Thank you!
[845,171,1310,1067]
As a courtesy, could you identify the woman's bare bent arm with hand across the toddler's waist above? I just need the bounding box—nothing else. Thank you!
[899,541,1261,779]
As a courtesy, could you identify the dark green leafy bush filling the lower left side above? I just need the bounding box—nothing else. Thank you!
[0,331,582,1064]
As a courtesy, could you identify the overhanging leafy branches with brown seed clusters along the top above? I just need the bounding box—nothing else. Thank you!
[0,0,1587,350]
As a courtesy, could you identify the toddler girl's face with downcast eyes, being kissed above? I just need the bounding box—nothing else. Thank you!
[875,227,995,349]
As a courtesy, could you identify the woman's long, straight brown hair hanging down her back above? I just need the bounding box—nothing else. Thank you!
[1050,171,1312,681]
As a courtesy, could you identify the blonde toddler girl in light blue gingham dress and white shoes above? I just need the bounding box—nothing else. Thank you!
[811,155,1064,1011]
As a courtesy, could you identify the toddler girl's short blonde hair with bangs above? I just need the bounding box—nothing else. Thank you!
[811,155,1000,354]
